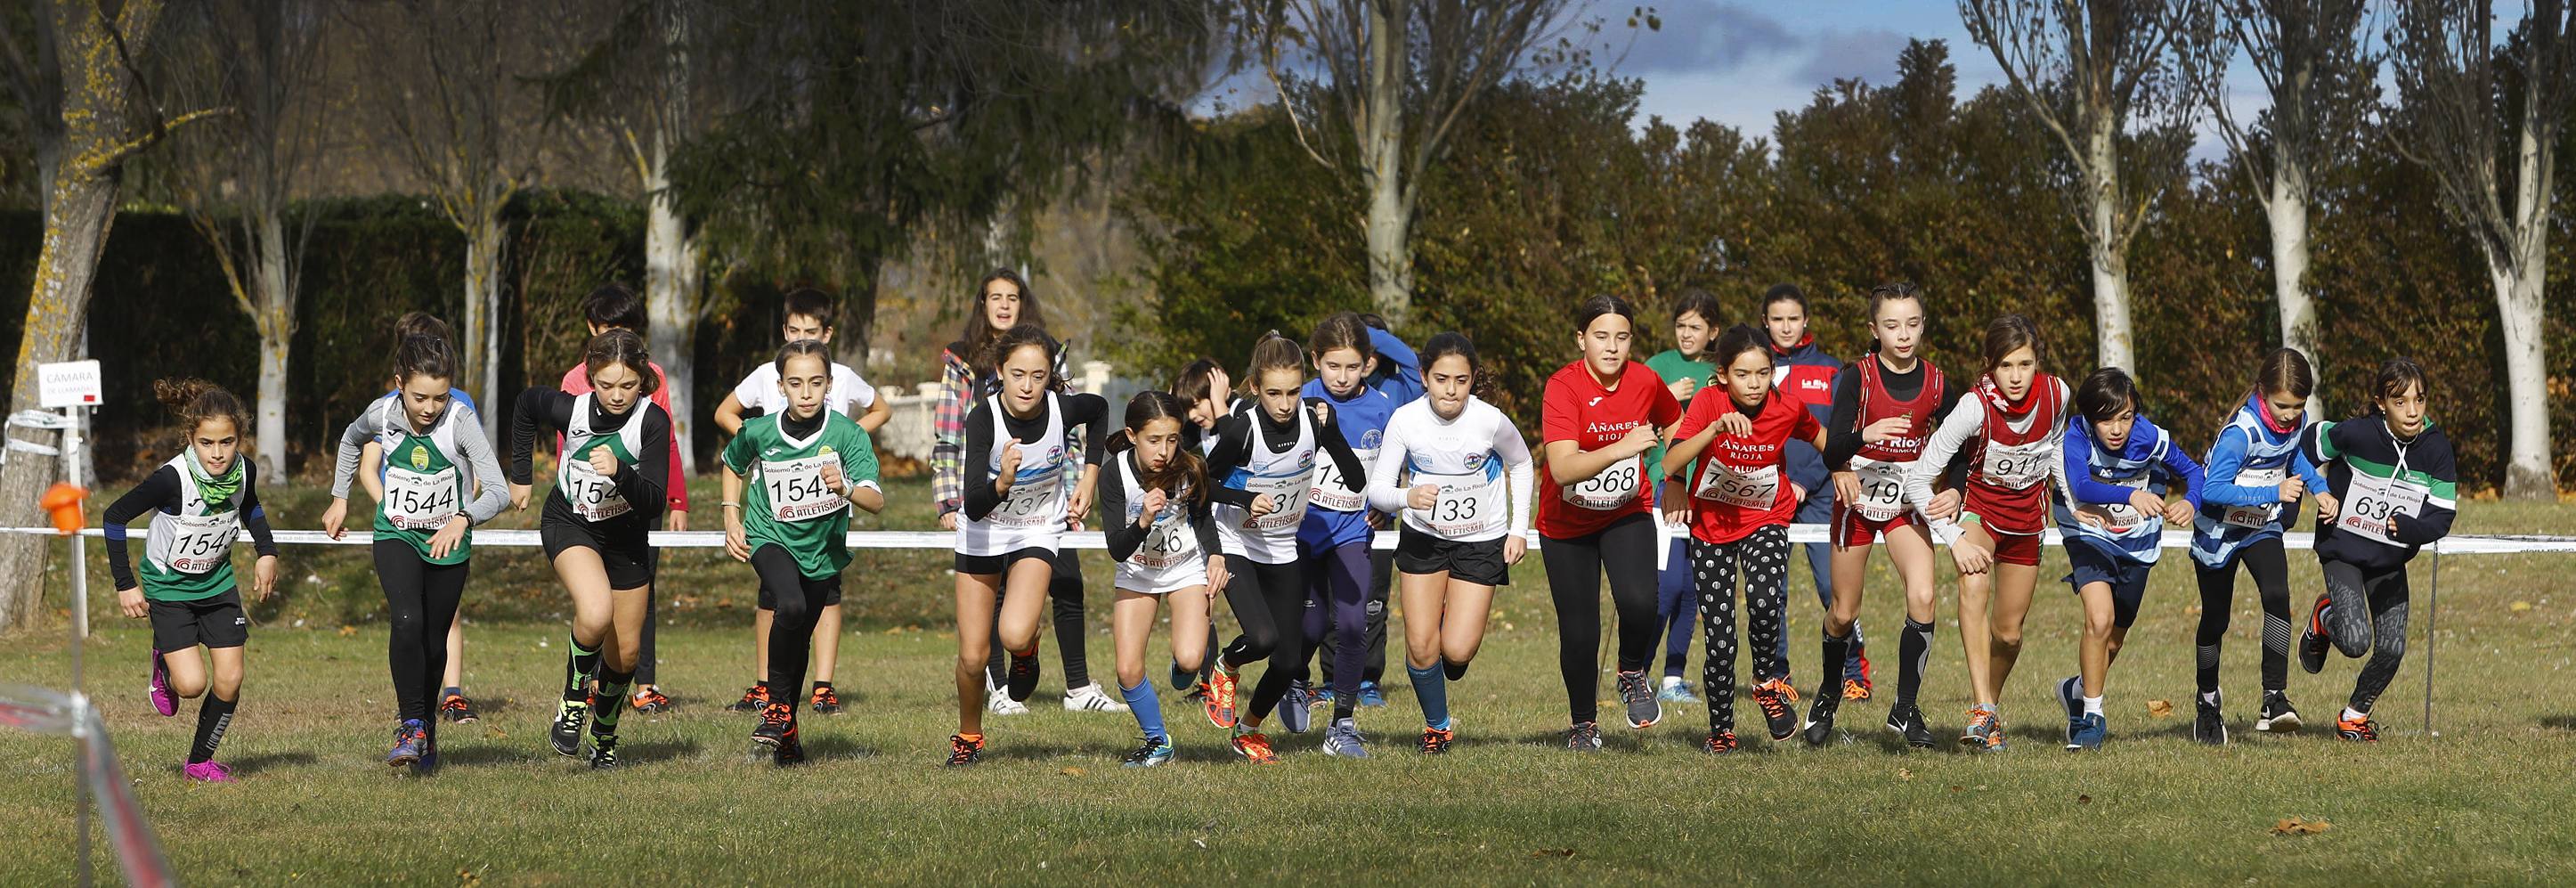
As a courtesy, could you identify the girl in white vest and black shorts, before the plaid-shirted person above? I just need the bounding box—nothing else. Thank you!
[947,324,1110,764]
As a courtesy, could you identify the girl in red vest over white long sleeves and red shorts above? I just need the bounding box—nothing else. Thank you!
[1906,314,2068,752]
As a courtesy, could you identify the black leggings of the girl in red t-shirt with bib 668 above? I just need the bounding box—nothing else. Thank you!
[1538,515,1664,723]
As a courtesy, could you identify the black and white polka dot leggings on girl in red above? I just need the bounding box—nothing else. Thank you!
[1690,525,1788,731]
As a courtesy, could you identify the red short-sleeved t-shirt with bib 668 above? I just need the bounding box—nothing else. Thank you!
[1538,361,1679,541]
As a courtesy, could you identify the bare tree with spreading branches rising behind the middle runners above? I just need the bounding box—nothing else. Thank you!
[1257,0,1587,324]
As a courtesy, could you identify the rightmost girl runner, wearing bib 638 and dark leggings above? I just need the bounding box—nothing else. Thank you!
[2298,358,2460,744]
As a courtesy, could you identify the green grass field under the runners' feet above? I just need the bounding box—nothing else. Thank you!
[0,473,2576,885]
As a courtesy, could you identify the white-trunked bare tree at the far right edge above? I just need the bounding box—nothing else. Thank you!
[2388,0,2576,497]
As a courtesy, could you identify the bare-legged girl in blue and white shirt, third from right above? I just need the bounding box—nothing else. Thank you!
[2059,368,2203,752]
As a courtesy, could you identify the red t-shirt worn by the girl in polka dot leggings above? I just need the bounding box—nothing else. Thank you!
[1674,388,1824,543]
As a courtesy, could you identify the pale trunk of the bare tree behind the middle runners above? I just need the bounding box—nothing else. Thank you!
[1361,0,1414,324]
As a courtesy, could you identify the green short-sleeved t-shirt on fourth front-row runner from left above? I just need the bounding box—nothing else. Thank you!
[724,411,876,579]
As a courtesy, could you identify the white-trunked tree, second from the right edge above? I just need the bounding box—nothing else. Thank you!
[2207,0,2380,361]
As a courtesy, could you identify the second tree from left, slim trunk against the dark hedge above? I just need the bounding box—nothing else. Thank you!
[170,0,325,479]
